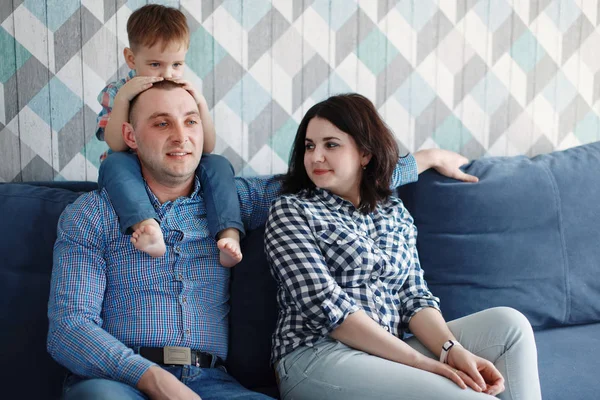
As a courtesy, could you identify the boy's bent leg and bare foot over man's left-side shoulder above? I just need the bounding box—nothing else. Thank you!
[98,152,165,257]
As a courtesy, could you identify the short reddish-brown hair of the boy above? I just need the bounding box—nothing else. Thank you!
[127,4,190,52]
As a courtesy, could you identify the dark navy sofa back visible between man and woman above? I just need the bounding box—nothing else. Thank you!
[227,228,278,395]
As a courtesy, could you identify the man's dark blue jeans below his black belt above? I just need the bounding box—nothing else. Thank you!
[62,365,271,400]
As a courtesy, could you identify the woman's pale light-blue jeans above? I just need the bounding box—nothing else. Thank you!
[276,307,542,400]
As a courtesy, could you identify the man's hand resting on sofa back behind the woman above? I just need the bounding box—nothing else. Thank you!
[414,149,479,182]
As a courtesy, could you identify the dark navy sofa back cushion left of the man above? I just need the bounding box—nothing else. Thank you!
[0,184,92,399]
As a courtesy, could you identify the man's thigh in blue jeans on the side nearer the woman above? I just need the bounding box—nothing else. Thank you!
[176,366,272,400]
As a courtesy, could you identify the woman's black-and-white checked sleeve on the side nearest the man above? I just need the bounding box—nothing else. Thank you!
[265,197,359,334]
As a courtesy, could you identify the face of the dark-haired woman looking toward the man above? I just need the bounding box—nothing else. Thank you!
[304,117,371,206]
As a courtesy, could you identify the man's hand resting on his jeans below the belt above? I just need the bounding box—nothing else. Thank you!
[137,365,202,400]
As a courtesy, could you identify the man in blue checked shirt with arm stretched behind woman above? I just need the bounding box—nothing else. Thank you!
[48,80,476,399]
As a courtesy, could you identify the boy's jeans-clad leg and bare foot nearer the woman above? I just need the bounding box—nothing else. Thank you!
[197,154,244,267]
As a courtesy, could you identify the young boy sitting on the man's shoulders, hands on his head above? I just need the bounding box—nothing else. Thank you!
[96,4,244,267]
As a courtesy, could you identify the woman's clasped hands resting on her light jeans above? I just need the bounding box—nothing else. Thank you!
[448,346,504,396]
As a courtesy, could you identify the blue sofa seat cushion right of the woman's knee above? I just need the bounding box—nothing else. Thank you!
[535,324,600,400]
